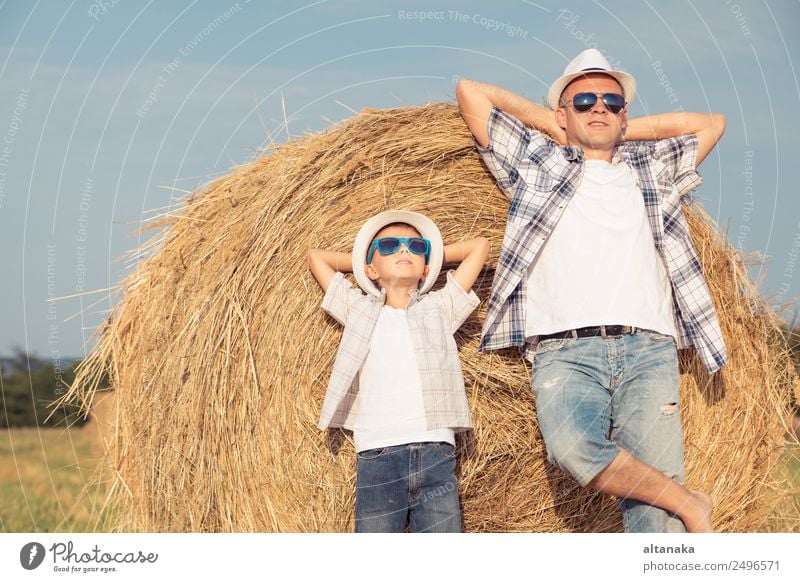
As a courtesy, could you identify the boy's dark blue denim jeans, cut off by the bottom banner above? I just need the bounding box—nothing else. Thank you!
[356,443,461,533]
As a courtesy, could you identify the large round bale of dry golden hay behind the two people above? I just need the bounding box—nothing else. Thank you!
[64,104,793,532]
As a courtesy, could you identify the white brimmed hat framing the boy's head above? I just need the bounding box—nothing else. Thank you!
[353,210,444,297]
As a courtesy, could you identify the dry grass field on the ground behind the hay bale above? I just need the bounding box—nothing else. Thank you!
[0,428,800,532]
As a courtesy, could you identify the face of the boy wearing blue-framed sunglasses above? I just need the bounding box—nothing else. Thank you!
[364,225,430,289]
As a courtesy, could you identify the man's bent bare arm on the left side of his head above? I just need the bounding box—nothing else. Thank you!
[456,79,566,147]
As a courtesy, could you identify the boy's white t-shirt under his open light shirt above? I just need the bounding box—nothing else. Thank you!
[353,305,455,452]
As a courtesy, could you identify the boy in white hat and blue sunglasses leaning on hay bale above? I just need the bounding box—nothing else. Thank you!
[308,211,489,532]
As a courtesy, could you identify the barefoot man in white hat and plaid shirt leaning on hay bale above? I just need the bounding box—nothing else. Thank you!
[456,49,727,532]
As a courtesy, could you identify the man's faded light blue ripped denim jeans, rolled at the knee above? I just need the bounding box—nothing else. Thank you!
[532,330,685,532]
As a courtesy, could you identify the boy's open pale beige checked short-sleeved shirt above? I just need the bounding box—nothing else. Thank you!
[317,271,480,432]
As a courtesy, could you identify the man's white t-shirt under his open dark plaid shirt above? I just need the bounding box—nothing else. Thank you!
[525,160,677,337]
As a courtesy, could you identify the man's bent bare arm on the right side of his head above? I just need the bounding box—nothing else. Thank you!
[625,112,725,166]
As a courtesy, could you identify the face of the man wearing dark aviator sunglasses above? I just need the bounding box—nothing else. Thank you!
[555,73,628,152]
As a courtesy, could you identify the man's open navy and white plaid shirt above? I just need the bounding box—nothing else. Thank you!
[478,107,728,373]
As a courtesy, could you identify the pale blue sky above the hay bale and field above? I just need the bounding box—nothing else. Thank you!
[0,0,800,358]
